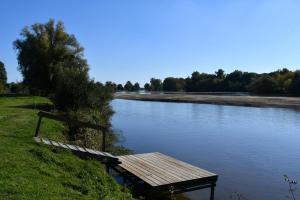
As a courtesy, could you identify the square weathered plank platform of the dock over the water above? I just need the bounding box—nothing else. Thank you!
[118,153,217,193]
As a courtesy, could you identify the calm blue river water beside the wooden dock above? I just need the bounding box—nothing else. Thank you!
[112,100,300,200]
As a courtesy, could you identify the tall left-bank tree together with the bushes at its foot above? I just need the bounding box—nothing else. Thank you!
[14,20,116,145]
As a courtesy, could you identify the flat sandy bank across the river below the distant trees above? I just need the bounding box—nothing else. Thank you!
[114,93,300,109]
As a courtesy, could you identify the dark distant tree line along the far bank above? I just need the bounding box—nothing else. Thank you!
[116,68,300,96]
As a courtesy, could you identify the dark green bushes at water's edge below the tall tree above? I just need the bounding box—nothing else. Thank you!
[52,69,113,144]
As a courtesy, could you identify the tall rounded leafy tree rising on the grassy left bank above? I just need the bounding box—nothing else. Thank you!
[14,20,88,95]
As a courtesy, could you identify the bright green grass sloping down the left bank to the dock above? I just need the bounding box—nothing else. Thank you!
[0,95,132,200]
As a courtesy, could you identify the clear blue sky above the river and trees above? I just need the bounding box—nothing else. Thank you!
[0,0,300,84]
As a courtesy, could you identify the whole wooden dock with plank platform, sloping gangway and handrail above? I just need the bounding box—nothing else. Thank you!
[34,111,218,200]
